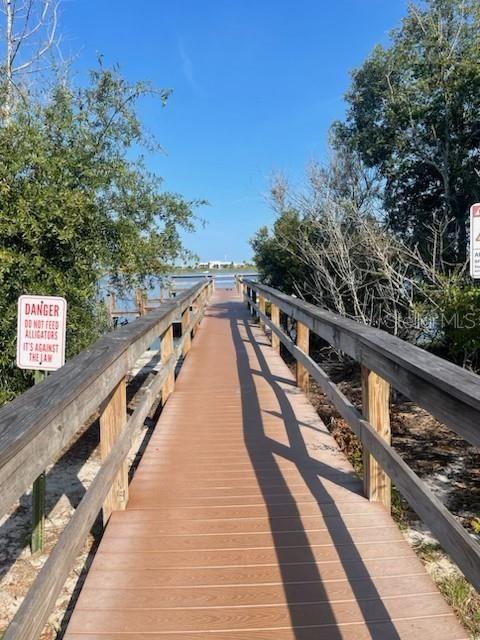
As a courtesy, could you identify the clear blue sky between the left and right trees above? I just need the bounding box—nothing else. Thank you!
[61,0,406,260]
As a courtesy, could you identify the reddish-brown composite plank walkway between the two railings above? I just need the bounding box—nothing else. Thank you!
[65,291,467,640]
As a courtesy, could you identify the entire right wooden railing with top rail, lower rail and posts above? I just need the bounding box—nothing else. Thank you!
[237,278,480,590]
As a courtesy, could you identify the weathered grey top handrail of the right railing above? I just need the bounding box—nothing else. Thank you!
[242,279,480,446]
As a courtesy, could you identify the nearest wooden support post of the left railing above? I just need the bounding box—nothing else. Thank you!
[100,378,128,525]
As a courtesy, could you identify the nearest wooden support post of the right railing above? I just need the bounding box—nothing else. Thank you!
[362,367,392,512]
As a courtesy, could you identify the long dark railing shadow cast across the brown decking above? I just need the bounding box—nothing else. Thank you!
[229,302,400,640]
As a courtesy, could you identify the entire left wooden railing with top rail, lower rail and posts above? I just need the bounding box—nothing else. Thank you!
[0,280,213,640]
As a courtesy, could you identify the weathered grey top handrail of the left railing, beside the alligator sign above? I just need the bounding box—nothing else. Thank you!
[0,282,209,514]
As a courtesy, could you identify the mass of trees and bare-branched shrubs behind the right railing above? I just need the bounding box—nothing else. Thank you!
[252,0,480,368]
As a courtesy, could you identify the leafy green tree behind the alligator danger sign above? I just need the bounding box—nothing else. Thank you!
[0,66,198,402]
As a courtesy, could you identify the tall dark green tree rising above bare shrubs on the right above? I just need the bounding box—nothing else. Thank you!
[336,0,480,263]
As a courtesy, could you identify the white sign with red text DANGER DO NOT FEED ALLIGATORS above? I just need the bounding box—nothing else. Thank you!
[17,296,67,371]
